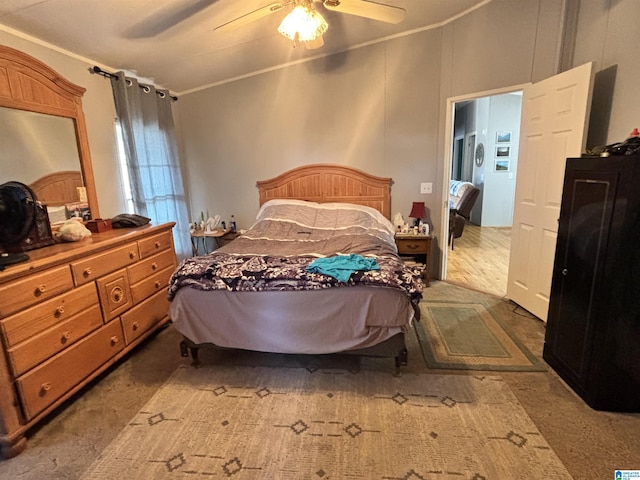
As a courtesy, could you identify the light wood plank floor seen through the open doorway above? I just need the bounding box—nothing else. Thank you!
[447,224,511,297]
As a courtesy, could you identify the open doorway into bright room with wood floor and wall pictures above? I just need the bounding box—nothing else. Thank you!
[441,86,523,296]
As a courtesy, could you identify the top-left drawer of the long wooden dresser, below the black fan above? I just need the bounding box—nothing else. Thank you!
[0,265,73,318]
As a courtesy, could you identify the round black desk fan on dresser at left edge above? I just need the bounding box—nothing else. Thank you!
[0,182,37,270]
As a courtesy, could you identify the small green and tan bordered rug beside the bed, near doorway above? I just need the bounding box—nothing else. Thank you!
[416,302,547,372]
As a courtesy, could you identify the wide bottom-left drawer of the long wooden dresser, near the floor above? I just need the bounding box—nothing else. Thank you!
[16,322,124,421]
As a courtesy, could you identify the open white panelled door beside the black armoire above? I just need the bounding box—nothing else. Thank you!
[507,63,593,322]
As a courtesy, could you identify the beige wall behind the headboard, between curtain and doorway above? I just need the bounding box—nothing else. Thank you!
[177,31,440,232]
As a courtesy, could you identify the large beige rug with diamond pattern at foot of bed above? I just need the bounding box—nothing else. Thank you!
[82,366,571,480]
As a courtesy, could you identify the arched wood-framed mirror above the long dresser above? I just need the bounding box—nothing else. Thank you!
[0,45,100,218]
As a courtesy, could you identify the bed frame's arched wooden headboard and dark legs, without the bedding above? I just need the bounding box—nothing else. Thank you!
[180,164,407,375]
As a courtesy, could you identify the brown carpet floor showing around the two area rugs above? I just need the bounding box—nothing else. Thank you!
[0,281,640,480]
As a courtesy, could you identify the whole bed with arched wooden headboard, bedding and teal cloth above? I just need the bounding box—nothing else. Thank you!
[169,164,423,373]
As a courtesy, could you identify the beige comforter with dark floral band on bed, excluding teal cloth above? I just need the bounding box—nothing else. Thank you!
[168,202,423,307]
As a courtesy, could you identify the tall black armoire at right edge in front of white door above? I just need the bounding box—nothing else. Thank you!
[543,156,640,412]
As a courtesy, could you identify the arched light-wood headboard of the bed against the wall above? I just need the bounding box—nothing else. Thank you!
[256,164,393,218]
